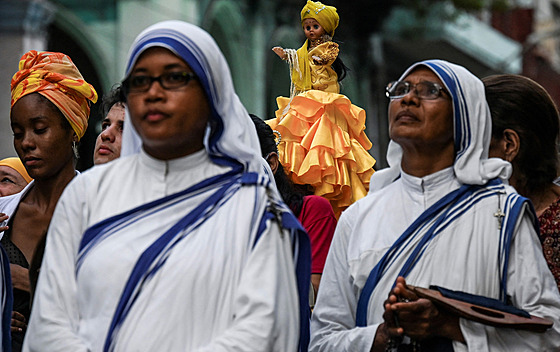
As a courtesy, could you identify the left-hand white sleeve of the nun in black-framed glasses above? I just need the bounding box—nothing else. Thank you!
[23,177,88,352]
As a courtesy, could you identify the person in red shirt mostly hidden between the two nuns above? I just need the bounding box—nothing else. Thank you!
[250,114,336,297]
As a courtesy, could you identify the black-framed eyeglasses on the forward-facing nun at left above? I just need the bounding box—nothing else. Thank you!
[123,71,196,93]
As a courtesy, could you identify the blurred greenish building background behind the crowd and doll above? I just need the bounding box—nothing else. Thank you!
[0,0,560,170]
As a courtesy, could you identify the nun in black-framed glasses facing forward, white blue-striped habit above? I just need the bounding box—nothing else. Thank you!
[25,21,310,352]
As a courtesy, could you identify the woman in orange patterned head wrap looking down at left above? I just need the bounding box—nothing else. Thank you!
[0,50,97,351]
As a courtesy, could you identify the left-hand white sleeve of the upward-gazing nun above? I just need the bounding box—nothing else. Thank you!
[309,213,379,352]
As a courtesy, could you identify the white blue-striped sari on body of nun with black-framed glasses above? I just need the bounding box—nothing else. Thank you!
[26,151,306,351]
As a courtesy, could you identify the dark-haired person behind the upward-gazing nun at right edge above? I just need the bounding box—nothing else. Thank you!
[482,74,560,289]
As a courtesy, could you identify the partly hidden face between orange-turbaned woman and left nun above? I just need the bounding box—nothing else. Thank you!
[93,84,126,165]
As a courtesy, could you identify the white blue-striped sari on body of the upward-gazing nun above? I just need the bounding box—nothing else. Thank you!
[310,168,560,352]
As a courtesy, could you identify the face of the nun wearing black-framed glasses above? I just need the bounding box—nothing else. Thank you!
[127,47,210,160]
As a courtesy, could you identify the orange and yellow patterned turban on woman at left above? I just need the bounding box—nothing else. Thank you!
[11,50,97,138]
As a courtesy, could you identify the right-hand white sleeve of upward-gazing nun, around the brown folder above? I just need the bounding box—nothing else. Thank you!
[454,210,560,352]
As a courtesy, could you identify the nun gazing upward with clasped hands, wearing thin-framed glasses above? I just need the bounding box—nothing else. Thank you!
[310,60,560,352]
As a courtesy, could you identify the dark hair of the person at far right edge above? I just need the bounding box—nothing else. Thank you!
[482,74,560,196]
